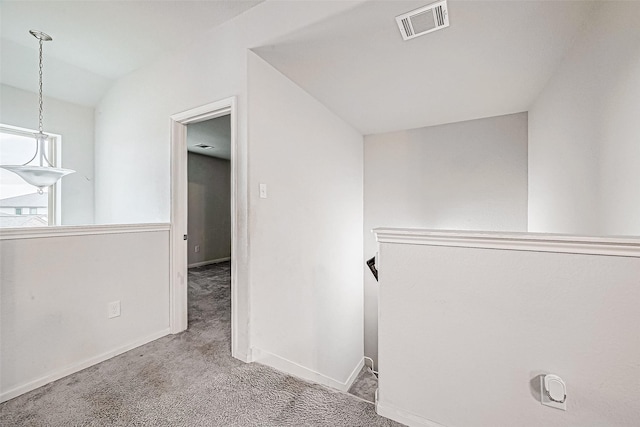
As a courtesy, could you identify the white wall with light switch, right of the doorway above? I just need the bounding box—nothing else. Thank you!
[248,53,363,388]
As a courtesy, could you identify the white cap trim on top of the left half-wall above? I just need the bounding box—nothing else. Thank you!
[0,223,171,240]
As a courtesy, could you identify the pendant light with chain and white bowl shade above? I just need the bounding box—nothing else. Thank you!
[0,30,75,194]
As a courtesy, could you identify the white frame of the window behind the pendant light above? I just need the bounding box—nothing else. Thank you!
[0,123,62,228]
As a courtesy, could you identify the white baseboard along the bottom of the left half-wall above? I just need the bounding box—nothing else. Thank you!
[0,329,169,402]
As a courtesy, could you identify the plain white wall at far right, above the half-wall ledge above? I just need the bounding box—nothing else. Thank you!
[529,2,640,235]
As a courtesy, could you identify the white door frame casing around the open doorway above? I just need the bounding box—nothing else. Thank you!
[169,97,250,361]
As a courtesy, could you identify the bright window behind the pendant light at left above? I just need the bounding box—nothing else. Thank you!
[0,124,60,228]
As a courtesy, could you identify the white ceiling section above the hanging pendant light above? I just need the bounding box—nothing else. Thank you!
[0,0,263,105]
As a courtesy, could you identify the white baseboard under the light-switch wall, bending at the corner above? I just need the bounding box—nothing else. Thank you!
[251,347,364,391]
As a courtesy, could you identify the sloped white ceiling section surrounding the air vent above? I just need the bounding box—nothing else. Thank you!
[255,0,596,134]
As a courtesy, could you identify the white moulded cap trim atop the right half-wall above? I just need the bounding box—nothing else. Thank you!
[373,228,640,258]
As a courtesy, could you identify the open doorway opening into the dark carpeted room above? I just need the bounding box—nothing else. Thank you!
[187,114,231,342]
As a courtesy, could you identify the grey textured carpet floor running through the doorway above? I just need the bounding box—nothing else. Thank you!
[0,263,399,426]
